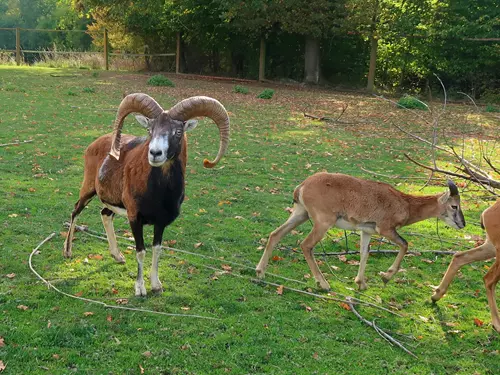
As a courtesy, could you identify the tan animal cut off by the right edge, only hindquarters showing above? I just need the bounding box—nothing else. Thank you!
[431,200,500,332]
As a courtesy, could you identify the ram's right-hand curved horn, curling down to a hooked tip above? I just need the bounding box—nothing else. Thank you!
[168,96,229,168]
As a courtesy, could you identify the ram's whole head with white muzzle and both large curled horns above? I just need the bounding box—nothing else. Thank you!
[110,93,229,168]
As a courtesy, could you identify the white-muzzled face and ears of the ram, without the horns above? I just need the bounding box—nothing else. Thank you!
[135,113,198,167]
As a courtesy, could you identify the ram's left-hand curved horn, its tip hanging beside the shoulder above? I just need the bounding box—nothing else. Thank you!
[109,93,163,160]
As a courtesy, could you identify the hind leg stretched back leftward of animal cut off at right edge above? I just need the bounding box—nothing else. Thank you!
[431,239,496,301]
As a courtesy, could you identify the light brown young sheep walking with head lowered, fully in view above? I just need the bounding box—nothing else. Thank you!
[256,173,465,290]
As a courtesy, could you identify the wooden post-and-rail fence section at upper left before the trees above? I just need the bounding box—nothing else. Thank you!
[0,27,180,72]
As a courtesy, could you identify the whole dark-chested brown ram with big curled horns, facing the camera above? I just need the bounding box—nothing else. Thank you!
[63,94,229,296]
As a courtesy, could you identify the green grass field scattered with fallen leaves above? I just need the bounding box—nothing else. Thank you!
[0,66,500,375]
